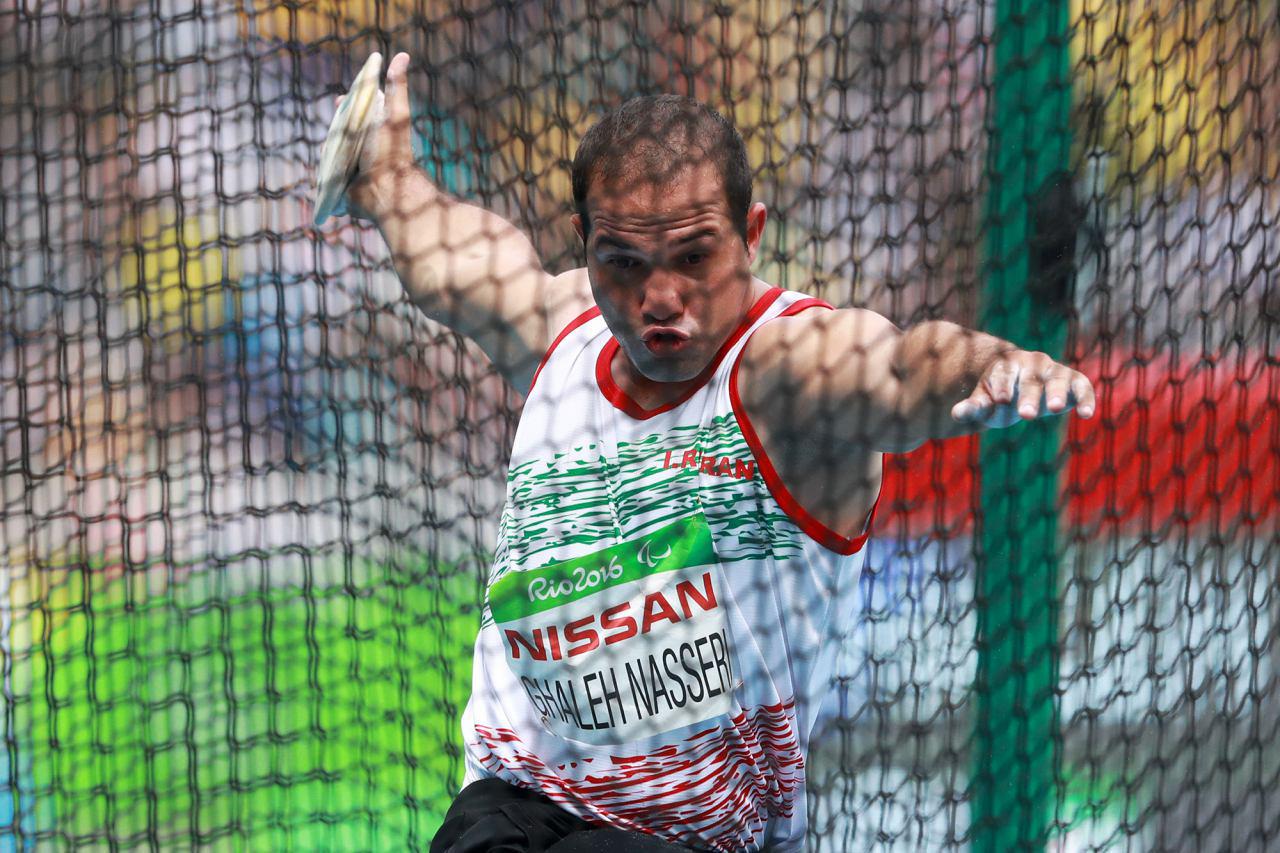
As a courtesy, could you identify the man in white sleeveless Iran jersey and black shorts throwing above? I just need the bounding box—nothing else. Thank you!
[337,54,1094,853]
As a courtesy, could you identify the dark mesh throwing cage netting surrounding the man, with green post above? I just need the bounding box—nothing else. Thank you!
[0,0,1280,850]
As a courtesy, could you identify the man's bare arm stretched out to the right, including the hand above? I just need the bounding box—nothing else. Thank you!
[742,309,1096,455]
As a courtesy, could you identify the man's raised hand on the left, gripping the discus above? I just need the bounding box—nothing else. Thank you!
[339,53,426,223]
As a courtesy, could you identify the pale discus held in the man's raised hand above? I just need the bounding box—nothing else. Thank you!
[314,53,383,227]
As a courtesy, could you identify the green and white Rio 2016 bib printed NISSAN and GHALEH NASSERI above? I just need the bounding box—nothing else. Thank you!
[489,512,733,744]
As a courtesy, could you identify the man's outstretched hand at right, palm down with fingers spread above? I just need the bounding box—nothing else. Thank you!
[951,350,1097,428]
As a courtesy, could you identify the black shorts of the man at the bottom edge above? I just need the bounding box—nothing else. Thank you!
[431,779,689,853]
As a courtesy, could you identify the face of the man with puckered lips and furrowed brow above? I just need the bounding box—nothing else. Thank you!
[573,163,765,382]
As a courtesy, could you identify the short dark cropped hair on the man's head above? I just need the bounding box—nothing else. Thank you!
[573,95,751,242]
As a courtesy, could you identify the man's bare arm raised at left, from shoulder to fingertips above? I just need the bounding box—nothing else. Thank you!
[347,54,591,393]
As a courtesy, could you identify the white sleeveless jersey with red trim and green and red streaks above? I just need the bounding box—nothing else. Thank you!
[462,288,880,850]
